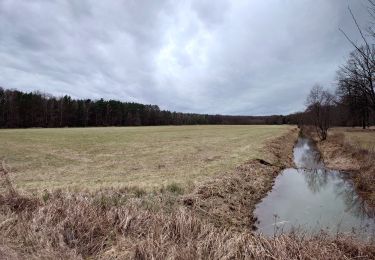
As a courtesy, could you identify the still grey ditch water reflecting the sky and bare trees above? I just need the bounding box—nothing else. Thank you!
[255,138,375,239]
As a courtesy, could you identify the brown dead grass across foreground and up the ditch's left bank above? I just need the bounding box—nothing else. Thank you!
[0,129,375,260]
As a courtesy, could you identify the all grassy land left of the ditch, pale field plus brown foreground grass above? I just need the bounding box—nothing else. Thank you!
[0,126,375,260]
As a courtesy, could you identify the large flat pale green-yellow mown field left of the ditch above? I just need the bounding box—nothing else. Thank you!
[0,126,291,190]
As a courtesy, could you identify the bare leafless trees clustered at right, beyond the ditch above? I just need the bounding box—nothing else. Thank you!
[287,0,375,140]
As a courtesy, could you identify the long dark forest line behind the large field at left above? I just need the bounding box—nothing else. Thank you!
[0,87,285,128]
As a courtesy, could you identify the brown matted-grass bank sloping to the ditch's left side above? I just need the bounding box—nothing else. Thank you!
[183,129,298,229]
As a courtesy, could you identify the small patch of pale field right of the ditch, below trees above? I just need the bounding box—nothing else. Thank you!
[334,128,375,152]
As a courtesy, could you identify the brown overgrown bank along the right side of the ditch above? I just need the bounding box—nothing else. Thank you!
[304,130,375,207]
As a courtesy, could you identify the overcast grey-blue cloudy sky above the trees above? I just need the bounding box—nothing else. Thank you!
[0,0,369,115]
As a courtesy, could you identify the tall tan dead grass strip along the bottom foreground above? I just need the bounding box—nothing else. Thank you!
[0,186,375,259]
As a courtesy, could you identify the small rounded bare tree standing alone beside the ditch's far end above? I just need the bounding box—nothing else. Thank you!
[306,85,334,141]
